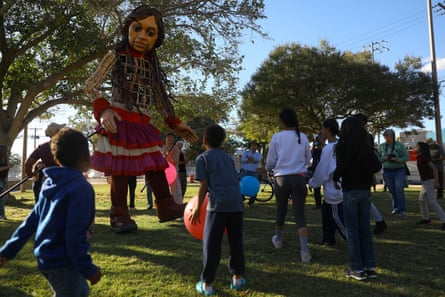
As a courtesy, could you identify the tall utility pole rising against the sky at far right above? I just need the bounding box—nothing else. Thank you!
[426,0,442,145]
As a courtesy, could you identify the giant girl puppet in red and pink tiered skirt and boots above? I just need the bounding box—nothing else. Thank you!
[86,5,198,233]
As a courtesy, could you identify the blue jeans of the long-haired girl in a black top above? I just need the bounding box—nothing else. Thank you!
[343,190,375,271]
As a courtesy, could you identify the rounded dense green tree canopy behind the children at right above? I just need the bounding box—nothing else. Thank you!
[240,42,433,141]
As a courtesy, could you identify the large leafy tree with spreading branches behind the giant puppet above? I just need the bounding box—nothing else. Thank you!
[0,0,264,153]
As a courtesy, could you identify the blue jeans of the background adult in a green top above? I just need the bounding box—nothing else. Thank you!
[383,167,406,213]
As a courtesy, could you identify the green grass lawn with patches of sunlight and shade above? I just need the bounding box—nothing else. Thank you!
[0,184,445,297]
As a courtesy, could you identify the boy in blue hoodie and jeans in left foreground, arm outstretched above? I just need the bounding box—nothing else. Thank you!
[0,128,101,297]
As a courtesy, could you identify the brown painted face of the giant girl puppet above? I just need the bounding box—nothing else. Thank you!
[128,16,158,53]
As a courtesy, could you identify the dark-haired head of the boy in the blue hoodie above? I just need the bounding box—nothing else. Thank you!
[51,128,90,167]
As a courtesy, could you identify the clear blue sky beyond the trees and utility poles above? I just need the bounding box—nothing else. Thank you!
[12,0,445,154]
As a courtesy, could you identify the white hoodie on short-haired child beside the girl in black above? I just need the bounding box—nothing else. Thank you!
[309,140,343,204]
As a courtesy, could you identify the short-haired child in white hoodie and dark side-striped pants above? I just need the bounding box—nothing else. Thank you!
[309,119,346,246]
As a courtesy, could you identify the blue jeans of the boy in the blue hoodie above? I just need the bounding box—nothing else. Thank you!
[42,267,90,297]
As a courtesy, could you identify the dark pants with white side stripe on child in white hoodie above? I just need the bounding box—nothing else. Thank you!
[321,201,346,245]
